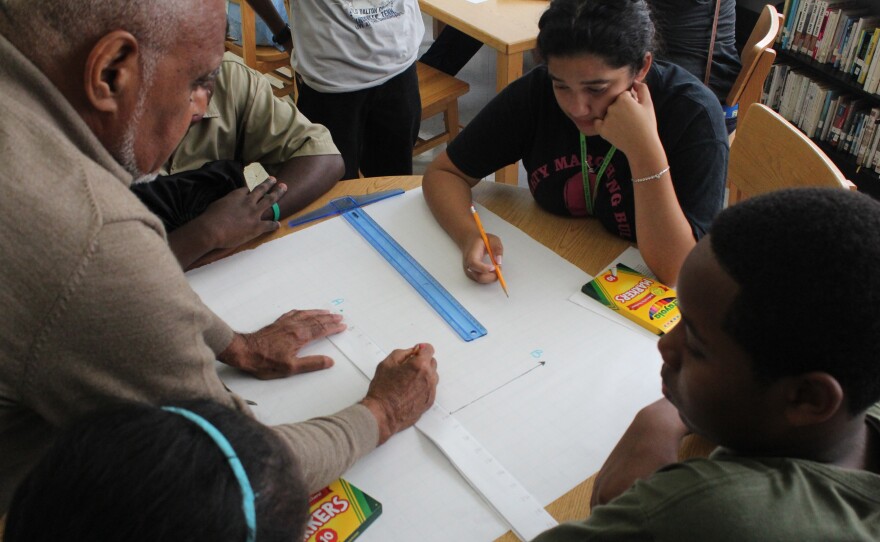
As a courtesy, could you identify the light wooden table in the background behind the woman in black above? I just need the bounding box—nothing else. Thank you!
[419,0,547,185]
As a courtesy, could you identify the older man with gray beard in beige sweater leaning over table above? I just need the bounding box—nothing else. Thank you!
[0,0,437,514]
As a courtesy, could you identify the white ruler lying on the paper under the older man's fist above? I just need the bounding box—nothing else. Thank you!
[329,325,557,540]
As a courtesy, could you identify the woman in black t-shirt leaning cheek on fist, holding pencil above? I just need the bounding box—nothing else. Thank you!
[422,0,728,284]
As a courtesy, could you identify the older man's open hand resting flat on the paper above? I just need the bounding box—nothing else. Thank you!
[219,310,346,379]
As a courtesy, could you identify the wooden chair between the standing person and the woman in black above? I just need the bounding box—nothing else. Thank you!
[413,62,470,156]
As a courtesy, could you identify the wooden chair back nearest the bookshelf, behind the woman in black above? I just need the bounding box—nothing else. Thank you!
[726,4,783,122]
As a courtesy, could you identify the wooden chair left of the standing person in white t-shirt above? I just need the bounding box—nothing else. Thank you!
[226,0,296,97]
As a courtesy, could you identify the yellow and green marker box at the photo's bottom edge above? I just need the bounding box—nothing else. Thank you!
[304,478,382,542]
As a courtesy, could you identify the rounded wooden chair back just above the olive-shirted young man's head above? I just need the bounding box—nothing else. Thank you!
[727,104,855,204]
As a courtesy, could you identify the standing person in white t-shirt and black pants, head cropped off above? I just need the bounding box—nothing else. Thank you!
[248,0,425,179]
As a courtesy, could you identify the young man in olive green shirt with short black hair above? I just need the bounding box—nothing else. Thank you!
[535,189,880,542]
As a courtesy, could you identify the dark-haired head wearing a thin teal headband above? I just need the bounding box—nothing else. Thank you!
[4,401,308,542]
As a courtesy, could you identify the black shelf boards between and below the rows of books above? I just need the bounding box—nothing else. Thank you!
[775,0,880,199]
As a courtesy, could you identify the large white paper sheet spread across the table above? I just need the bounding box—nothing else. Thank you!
[188,190,660,541]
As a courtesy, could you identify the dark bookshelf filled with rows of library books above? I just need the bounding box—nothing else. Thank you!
[764,0,880,199]
